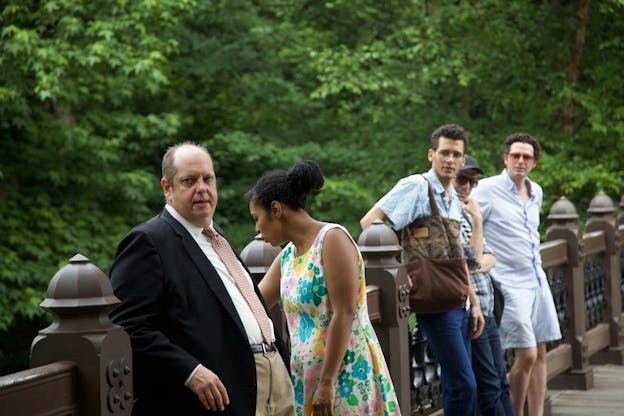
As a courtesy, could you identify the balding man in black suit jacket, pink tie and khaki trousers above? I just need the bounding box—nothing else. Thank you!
[110,142,294,416]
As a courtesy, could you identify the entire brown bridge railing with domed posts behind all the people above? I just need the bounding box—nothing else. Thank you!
[0,193,624,416]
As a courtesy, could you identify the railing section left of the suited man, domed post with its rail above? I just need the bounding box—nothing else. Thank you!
[0,254,133,416]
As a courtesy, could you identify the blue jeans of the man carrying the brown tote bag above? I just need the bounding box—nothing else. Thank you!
[416,308,477,416]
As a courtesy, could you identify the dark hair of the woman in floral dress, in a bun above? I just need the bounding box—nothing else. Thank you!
[247,160,325,211]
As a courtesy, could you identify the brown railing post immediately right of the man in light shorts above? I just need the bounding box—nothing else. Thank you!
[546,196,594,390]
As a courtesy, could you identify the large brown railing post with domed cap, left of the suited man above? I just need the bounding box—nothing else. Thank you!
[30,254,133,415]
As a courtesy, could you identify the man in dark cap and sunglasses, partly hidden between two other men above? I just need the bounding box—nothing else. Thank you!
[453,155,514,416]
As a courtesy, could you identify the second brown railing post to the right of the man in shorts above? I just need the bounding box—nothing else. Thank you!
[585,191,624,365]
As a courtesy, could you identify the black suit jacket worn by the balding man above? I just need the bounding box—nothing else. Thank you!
[110,210,289,416]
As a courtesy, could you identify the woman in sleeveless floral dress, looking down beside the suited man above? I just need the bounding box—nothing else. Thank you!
[248,161,400,416]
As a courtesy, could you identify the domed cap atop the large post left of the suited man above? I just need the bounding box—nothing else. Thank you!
[40,253,120,315]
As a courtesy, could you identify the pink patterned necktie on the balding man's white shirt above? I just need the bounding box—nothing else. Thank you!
[203,228,274,344]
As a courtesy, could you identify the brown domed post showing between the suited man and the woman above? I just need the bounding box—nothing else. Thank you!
[240,234,290,346]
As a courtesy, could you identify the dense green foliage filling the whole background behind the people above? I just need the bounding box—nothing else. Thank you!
[0,0,624,366]
